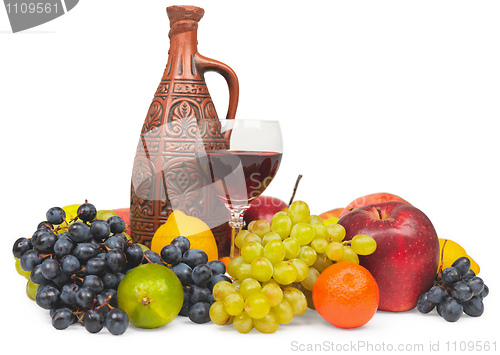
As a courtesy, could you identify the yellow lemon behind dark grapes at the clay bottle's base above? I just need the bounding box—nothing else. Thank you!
[151,210,219,261]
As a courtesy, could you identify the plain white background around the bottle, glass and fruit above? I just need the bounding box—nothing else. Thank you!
[0,0,500,353]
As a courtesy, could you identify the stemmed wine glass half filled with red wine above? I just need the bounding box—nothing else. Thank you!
[196,119,283,258]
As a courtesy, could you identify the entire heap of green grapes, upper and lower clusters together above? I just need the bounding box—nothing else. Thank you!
[210,201,376,333]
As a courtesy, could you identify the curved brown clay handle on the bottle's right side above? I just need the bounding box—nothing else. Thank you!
[196,53,240,119]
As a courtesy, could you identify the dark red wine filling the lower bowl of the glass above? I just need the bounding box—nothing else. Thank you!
[206,149,282,210]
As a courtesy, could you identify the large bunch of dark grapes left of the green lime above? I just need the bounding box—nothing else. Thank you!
[12,202,145,335]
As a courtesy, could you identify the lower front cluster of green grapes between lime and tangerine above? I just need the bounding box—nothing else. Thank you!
[210,277,307,333]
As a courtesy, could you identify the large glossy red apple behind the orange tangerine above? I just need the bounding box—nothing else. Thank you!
[338,201,439,312]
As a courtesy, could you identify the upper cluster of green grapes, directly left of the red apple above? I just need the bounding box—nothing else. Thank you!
[228,201,377,307]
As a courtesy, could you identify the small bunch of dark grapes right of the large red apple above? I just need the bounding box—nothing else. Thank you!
[417,257,489,322]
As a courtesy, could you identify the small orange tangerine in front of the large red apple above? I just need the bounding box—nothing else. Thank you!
[312,261,379,328]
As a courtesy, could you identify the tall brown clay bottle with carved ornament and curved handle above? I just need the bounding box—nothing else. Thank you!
[130,6,239,257]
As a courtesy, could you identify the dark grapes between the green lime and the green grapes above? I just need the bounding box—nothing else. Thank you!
[160,236,231,324]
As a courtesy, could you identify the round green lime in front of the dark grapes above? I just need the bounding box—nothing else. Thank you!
[118,264,184,329]
